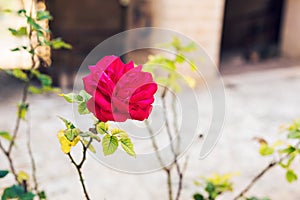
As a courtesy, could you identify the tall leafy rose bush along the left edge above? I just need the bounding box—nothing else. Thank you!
[0,1,71,200]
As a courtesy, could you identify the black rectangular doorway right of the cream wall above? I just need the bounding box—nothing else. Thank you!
[221,0,283,67]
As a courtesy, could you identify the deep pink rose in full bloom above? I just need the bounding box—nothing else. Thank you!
[83,56,157,122]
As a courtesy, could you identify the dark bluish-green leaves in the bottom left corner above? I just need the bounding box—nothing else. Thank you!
[1,185,35,200]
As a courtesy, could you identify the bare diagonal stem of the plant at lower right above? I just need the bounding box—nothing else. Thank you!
[234,143,300,200]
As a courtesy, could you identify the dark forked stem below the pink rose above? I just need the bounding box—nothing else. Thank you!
[67,138,93,200]
